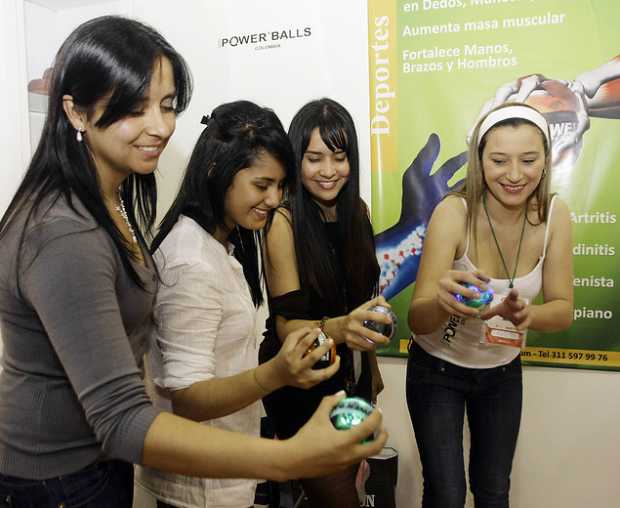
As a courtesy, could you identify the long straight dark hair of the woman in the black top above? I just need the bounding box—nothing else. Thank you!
[288,98,379,308]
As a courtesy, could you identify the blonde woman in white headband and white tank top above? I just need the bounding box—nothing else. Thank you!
[407,104,573,508]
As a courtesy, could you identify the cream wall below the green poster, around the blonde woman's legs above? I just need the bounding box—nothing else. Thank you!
[379,358,620,508]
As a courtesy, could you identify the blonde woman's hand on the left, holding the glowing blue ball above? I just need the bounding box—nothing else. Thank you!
[437,270,489,318]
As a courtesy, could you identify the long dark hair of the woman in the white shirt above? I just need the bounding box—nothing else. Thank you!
[151,101,295,306]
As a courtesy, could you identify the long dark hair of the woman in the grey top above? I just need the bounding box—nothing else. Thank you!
[0,16,191,287]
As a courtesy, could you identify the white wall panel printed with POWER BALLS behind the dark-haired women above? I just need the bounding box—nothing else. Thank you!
[133,0,370,222]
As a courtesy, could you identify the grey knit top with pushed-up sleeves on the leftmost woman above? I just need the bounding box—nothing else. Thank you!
[0,192,162,479]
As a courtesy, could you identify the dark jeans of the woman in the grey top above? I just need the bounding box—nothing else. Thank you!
[0,461,133,508]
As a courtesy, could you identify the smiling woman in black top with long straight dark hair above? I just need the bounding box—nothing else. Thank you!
[260,99,389,508]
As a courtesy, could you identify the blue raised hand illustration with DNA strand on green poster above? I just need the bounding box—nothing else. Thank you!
[375,133,467,300]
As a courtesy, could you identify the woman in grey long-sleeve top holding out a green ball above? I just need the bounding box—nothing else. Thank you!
[0,12,386,508]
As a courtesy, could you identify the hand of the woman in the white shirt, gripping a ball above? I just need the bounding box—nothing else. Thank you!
[271,327,340,388]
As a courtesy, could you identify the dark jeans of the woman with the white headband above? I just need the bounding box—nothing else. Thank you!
[407,343,523,508]
